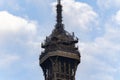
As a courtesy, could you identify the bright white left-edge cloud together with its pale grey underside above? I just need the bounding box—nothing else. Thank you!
[0,11,37,39]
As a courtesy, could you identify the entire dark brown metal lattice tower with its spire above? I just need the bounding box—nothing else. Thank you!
[39,0,80,80]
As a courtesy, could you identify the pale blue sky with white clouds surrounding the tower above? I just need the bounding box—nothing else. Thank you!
[0,0,120,80]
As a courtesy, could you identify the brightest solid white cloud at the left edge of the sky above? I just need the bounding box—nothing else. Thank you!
[0,11,36,34]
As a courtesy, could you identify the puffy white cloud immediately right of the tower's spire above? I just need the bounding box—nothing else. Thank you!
[54,0,98,31]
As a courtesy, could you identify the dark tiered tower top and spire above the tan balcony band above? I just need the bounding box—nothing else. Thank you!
[40,0,80,58]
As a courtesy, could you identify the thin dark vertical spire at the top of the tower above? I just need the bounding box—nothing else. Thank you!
[57,0,62,24]
